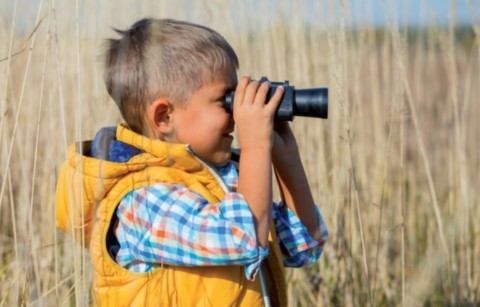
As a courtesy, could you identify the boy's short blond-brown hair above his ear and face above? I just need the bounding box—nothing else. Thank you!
[104,19,238,133]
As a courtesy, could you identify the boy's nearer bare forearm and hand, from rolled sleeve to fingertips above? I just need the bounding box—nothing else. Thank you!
[233,77,283,248]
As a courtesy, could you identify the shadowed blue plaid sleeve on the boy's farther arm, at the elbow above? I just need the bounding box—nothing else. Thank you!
[273,202,328,267]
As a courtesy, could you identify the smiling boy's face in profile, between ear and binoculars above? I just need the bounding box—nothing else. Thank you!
[172,74,237,165]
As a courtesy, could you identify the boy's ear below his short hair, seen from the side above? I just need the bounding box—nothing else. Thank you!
[147,98,173,139]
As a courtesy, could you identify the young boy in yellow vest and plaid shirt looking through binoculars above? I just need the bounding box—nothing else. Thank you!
[57,19,327,306]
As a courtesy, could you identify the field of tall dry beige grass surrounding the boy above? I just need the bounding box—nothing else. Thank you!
[0,0,480,306]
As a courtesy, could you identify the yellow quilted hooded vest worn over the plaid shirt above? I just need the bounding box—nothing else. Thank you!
[56,125,287,306]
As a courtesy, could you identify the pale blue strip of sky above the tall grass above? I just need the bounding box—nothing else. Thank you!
[0,0,480,32]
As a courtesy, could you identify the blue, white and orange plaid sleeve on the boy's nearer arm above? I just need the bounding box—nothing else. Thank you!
[115,183,268,280]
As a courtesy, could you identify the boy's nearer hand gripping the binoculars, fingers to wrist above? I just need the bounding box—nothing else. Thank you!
[233,77,283,151]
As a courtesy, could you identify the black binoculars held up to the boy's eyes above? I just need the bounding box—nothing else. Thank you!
[224,77,328,121]
